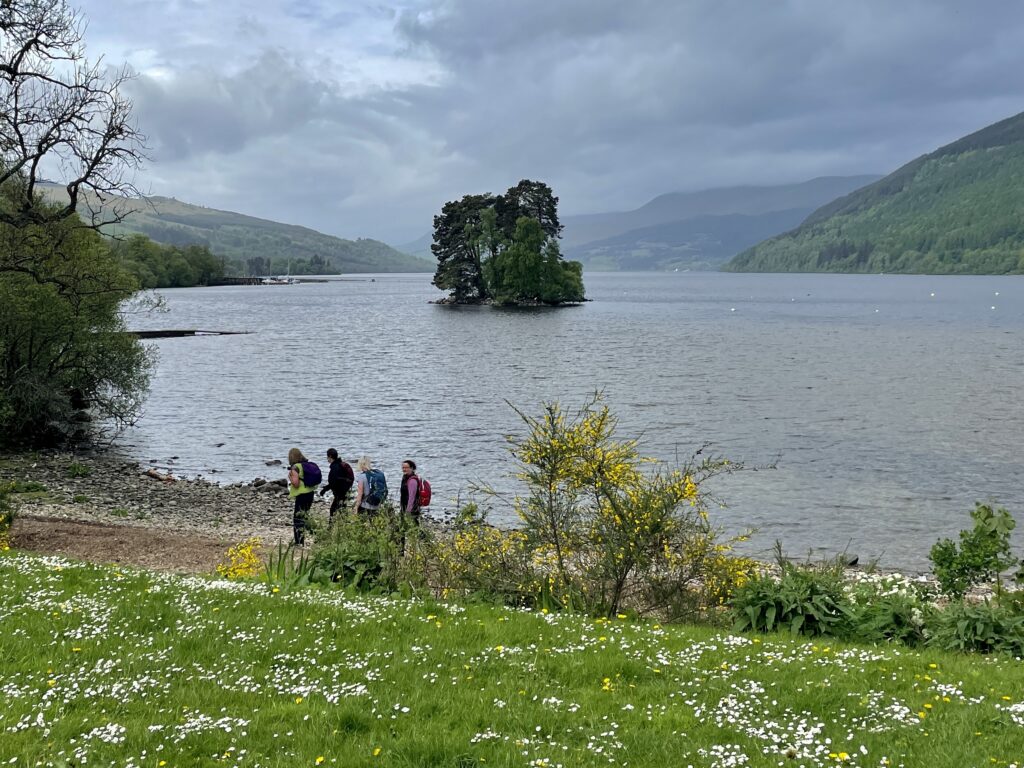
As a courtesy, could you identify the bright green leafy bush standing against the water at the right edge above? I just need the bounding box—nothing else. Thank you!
[929,503,1018,597]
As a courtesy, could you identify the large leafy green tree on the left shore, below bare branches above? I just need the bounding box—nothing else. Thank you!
[0,201,152,444]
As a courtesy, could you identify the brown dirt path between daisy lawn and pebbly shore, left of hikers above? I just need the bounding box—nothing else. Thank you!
[11,514,234,573]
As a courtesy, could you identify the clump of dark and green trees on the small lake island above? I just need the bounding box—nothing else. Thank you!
[430,179,584,305]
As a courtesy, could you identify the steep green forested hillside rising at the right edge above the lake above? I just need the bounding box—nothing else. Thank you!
[726,113,1024,274]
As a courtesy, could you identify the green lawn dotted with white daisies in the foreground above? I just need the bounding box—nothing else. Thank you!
[0,553,1024,768]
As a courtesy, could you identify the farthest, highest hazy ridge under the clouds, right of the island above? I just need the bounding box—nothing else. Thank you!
[562,175,879,248]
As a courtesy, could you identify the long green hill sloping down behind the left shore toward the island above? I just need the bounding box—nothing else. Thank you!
[43,184,434,272]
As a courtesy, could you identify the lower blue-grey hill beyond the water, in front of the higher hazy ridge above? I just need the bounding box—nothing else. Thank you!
[565,208,811,270]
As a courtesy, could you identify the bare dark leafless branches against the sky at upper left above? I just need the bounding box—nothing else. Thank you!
[0,0,143,228]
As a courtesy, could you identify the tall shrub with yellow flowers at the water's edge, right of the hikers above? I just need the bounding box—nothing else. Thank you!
[460,394,746,618]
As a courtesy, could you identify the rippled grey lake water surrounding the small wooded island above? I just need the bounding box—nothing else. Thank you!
[118,272,1024,569]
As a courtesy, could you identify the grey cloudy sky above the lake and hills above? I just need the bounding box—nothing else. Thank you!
[73,0,1024,244]
